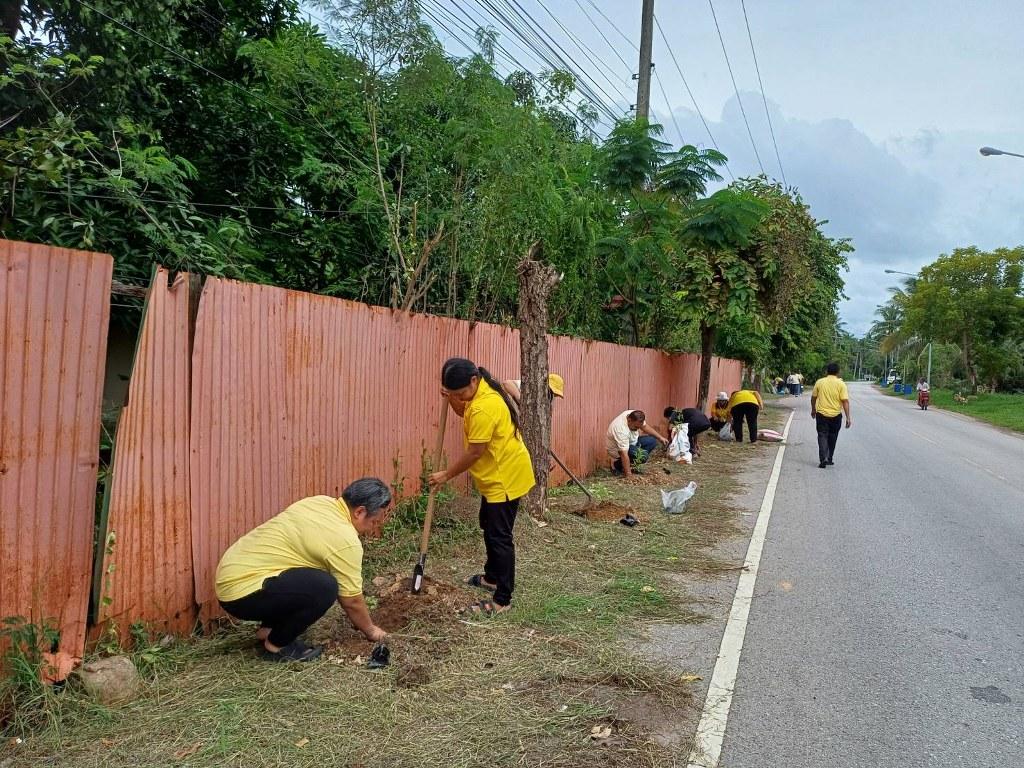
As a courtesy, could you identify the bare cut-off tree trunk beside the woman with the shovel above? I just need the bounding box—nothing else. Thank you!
[519,243,560,519]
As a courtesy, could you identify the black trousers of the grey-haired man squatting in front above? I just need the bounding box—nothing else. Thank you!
[220,568,338,646]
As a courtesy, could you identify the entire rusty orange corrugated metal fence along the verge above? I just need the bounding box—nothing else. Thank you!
[0,244,740,643]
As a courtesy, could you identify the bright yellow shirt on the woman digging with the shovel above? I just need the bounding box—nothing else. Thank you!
[462,379,535,502]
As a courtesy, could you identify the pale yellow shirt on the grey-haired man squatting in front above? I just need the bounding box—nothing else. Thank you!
[216,496,362,602]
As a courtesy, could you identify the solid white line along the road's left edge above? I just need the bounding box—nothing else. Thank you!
[687,414,794,768]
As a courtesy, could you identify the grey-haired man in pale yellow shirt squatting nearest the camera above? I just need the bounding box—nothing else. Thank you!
[216,477,391,662]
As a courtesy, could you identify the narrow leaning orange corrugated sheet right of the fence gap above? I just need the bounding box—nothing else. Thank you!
[98,268,196,637]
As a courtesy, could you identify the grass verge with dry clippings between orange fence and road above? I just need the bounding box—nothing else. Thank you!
[0,410,772,768]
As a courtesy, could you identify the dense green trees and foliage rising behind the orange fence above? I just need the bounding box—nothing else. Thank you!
[0,0,841,366]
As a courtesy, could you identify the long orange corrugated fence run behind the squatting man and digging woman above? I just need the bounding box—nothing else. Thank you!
[190,280,745,615]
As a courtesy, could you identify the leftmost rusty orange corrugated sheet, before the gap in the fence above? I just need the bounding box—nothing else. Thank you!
[0,241,113,676]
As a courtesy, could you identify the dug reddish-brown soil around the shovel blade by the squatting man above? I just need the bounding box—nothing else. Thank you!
[308,574,479,659]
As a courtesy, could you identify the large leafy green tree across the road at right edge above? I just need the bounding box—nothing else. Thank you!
[900,246,1024,392]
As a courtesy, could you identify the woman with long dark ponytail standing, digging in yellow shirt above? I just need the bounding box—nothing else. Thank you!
[429,357,535,616]
